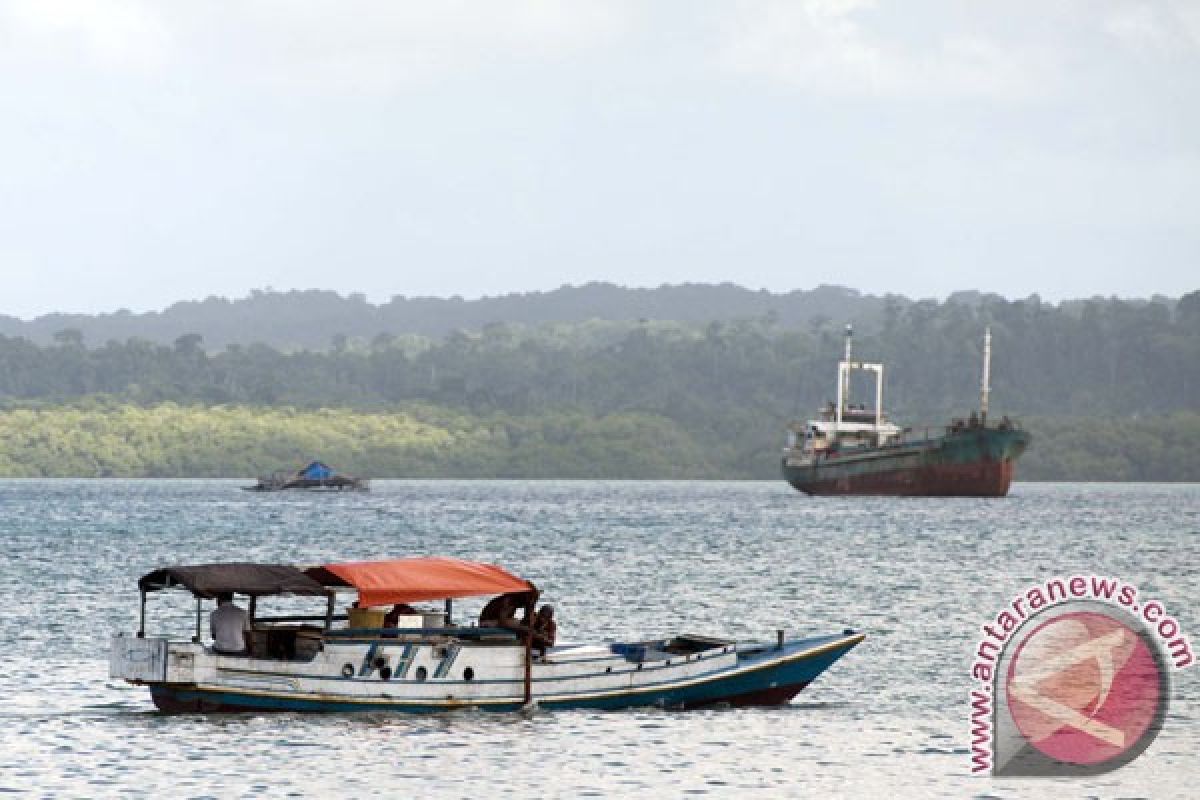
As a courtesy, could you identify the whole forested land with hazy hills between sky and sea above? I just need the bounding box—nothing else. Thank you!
[0,284,1200,481]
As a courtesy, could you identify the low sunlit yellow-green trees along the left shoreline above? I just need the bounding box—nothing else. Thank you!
[0,403,721,479]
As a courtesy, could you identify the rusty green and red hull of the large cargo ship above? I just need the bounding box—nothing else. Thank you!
[782,427,1030,498]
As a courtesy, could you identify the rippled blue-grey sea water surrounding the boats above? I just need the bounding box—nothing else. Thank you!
[0,481,1200,798]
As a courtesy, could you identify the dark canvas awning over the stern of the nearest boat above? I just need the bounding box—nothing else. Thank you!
[138,564,329,597]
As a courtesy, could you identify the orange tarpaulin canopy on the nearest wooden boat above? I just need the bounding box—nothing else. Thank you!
[306,558,534,606]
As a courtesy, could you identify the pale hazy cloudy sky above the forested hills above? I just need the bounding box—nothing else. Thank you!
[0,0,1200,318]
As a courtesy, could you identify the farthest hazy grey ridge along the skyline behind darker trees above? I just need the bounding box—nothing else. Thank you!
[0,283,902,350]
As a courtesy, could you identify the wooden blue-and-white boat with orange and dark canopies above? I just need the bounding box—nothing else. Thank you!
[109,558,864,712]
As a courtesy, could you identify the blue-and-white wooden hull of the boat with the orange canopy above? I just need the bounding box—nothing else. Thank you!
[129,633,864,714]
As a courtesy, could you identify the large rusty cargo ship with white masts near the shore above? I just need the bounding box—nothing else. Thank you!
[782,325,1031,498]
